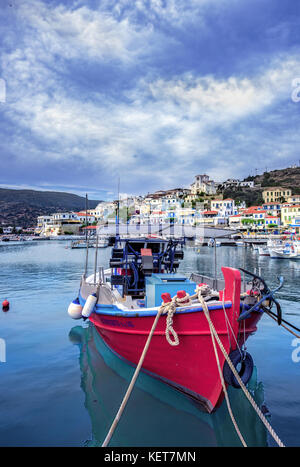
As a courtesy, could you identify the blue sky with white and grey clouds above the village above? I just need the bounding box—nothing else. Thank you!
[0,0,300,199]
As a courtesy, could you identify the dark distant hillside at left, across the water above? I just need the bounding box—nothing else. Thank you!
[0,188,101,227]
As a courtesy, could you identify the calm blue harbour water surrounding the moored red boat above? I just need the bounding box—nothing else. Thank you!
[0,241,300,446]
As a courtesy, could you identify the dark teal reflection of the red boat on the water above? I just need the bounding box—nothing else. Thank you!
[69,324,267,447]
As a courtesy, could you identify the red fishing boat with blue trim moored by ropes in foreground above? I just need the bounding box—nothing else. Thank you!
[69,239,284,412]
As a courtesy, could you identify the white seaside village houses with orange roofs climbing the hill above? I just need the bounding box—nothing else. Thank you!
[35,174,300,236]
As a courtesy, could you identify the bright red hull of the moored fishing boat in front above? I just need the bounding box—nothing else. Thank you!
[89,268,259,412]
